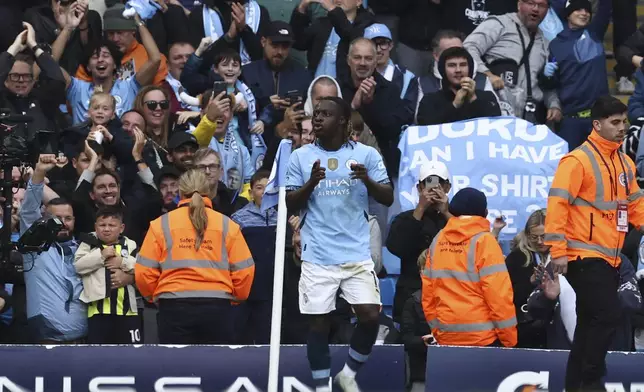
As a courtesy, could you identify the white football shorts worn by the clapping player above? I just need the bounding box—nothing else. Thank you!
[299,259,381,314]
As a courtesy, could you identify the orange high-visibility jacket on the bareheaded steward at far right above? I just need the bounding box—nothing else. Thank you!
[545,130,644,267]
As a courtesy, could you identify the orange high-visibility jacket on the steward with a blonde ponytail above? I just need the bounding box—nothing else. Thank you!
[134,197,255,302]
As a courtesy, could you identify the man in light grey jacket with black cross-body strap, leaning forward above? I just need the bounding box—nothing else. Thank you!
[463,0,562,124]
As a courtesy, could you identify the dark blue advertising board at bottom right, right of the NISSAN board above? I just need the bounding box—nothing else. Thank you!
[425,346,644,392]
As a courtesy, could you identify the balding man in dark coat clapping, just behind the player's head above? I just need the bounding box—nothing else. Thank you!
[339,38,414,177]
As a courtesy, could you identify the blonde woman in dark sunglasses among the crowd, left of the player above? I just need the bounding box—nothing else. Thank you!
[134,86,170,175]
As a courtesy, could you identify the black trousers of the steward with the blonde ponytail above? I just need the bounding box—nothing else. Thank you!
[157,298,235,344]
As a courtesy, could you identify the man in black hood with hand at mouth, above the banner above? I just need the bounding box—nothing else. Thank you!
[418,46,501,125]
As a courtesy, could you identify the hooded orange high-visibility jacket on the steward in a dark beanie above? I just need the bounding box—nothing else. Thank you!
[422,216,517,347]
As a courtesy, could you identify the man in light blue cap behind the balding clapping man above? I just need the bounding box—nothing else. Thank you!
[364,23,418,121]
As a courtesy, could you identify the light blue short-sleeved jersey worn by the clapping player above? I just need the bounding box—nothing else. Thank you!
[286,142,389,265]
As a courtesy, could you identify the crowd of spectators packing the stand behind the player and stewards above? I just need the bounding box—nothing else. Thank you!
[0,0,644,388]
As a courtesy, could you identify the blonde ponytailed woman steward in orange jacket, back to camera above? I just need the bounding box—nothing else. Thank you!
[135,169,255,344]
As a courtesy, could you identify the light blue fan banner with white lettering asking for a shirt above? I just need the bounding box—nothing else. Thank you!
[398,117,568,241]
